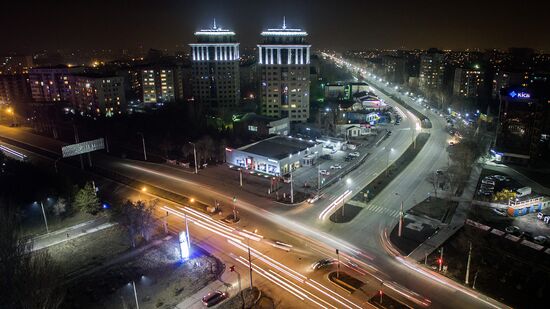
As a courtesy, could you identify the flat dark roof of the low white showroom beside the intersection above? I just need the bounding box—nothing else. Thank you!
[239,136,316,160]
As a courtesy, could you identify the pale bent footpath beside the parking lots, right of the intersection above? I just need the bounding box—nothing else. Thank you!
[408,164,483,261]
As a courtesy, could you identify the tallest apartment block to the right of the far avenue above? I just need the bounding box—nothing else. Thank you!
[419,49,445,91]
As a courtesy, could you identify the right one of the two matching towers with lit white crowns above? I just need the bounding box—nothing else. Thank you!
[258,19,311,122]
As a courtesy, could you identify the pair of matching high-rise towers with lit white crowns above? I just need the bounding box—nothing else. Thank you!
[189,20,311,122]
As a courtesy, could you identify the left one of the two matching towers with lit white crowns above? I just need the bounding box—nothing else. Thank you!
[189,20,240,111]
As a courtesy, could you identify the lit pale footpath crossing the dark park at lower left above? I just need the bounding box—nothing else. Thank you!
[29,217,116,251]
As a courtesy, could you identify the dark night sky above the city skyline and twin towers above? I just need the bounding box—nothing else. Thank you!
[4,0,550,52]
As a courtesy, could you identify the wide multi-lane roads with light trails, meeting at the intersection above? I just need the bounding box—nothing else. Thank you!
[0,58,504,308]
